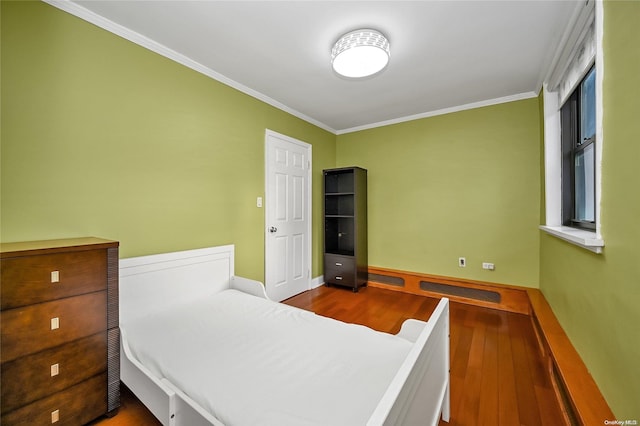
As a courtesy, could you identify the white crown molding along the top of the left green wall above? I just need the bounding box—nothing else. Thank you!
[43,0,336,134]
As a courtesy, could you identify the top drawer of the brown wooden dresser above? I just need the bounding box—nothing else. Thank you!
[0,250,107,310]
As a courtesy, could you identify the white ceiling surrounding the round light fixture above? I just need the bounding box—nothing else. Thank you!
[61,0,584,134]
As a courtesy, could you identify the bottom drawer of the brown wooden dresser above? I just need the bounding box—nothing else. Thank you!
[2,373,107,426]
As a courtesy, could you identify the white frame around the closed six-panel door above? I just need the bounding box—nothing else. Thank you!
[263,128,313,300]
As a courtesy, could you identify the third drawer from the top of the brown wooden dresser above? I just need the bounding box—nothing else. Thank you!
[1,332,107,414]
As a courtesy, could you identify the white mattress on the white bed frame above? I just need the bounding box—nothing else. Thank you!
[121,290,411,426]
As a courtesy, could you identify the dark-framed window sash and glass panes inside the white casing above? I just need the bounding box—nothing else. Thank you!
[560,67,596,230]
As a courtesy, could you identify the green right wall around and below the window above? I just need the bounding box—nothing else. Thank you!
[540,1,640,420]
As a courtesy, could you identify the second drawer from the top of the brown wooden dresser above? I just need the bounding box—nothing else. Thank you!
[1,291,107,362]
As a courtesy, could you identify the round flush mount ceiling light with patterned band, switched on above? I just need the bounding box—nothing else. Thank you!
[331,29,389,78]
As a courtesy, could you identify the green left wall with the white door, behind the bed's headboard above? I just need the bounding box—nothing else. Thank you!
[0,1,336,280]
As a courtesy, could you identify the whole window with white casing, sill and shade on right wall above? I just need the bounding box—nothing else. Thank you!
[540,0,606,253]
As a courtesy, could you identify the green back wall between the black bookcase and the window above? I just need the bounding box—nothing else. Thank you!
[337,98,540,287]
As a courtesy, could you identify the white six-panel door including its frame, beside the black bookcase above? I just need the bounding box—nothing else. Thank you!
[265,130,311,301]
